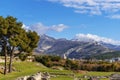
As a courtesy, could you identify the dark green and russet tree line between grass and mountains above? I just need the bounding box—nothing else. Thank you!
[35,55,120,72]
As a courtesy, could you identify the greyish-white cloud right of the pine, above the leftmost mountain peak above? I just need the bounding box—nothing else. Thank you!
[23,23,68,34]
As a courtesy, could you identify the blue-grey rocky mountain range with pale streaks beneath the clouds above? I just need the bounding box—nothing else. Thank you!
[35,35,120,59]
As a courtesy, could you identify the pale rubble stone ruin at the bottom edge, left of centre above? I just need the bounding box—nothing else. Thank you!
[16,72,50,80]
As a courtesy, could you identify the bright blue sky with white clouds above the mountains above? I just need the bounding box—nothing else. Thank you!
[0,0,120,44]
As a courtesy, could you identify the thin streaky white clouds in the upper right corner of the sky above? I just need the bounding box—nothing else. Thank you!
[48,0,120,15]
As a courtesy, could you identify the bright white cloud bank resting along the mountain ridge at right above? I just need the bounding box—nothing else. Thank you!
[73,34,120,45]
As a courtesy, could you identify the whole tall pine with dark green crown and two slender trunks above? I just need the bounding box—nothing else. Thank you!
[0,16,39,74]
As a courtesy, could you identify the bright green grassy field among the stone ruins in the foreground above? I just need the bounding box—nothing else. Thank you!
[0,62,118,80]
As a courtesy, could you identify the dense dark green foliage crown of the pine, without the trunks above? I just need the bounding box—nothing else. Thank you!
[0,16,39,55]
